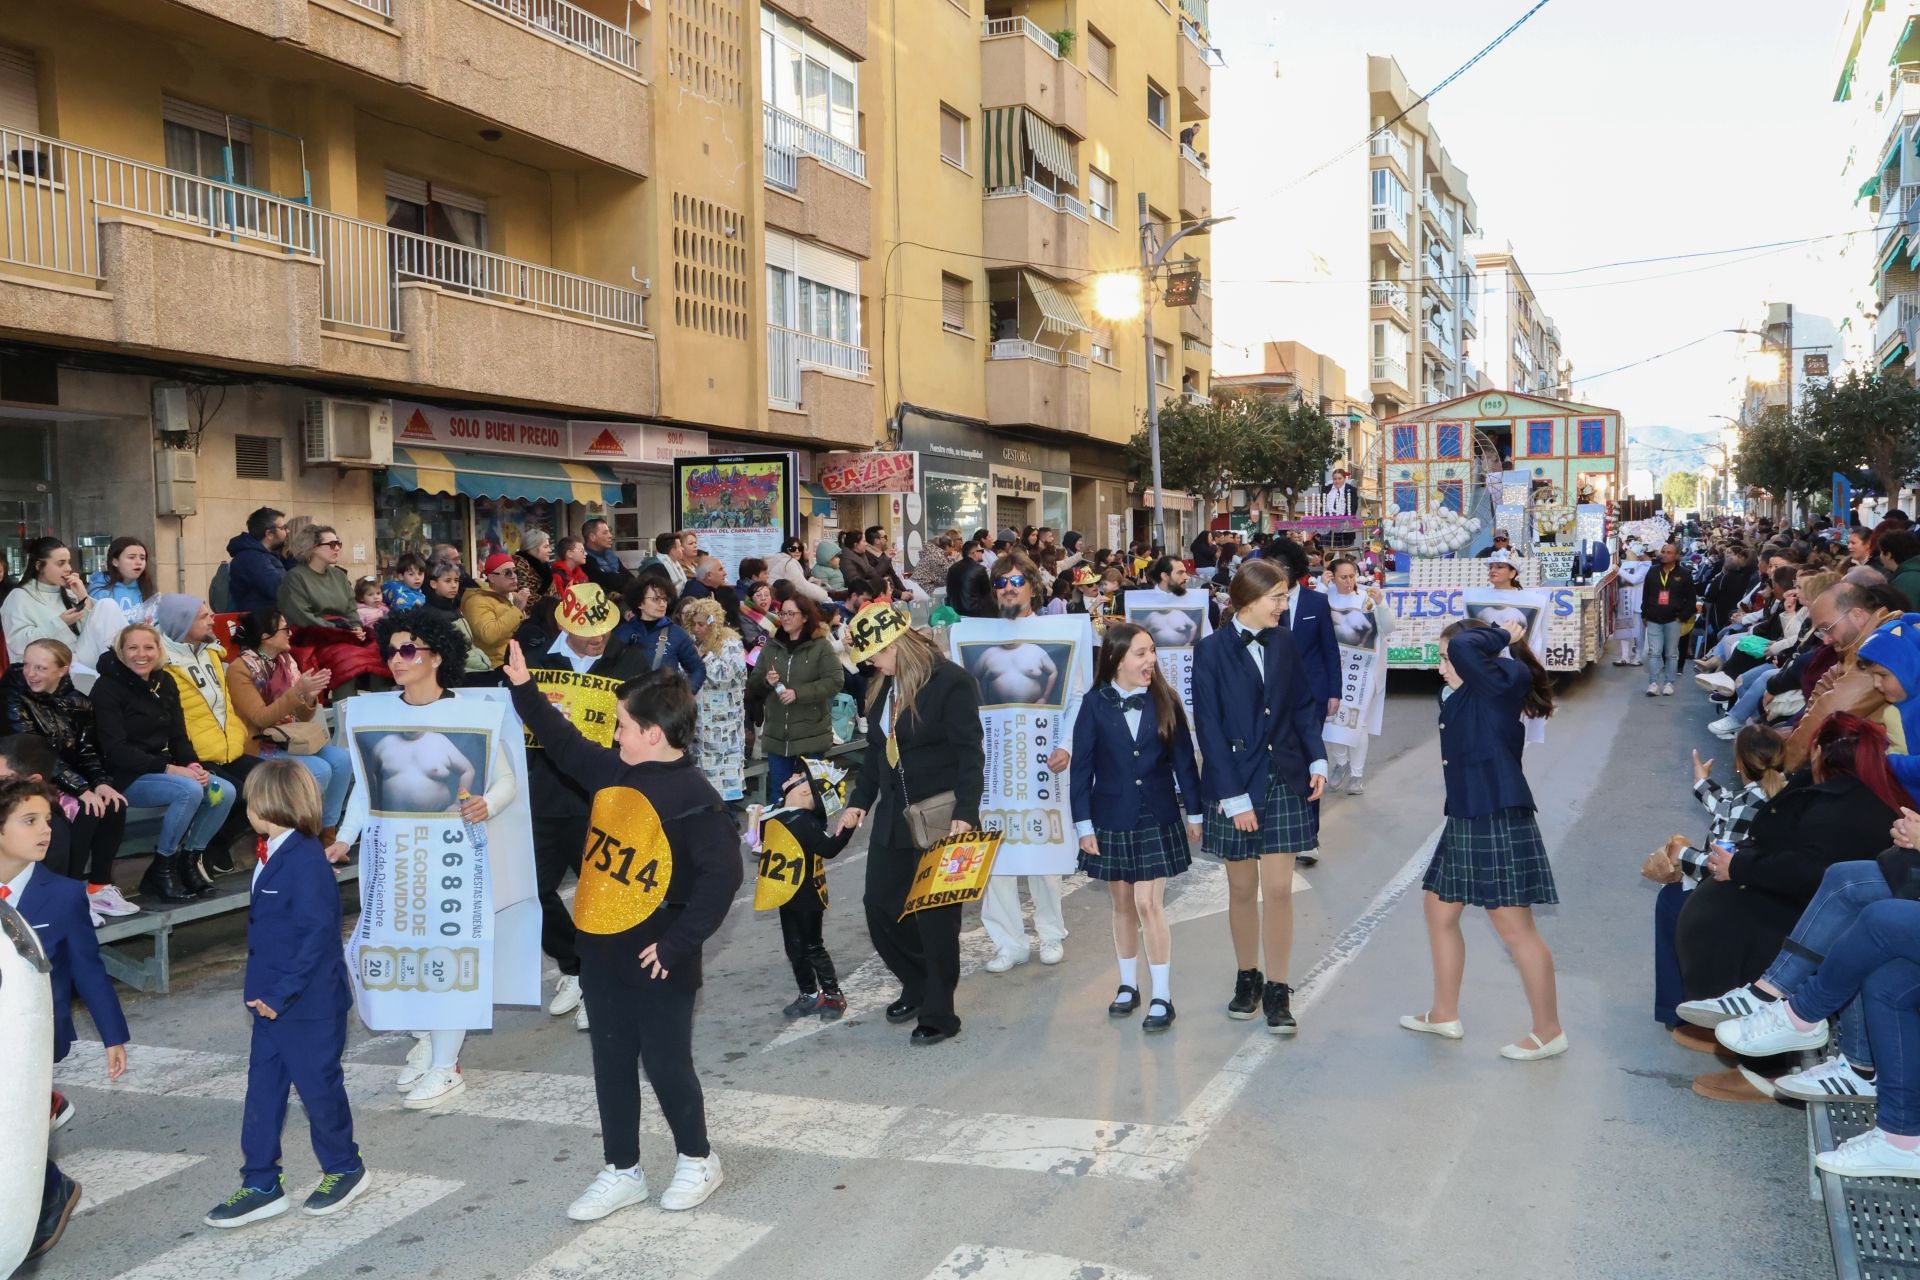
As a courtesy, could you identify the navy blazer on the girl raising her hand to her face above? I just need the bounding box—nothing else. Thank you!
[1440,628,1534,818]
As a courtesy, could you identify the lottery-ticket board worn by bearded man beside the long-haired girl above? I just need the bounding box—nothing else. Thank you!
[947,614,1092,875]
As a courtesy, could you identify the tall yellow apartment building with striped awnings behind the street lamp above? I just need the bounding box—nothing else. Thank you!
[870,0,1215,549]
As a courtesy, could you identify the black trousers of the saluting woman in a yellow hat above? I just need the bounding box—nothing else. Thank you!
[866,800,960,1031]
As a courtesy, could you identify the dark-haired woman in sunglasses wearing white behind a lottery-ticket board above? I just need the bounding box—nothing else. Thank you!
[326,608,520,1111]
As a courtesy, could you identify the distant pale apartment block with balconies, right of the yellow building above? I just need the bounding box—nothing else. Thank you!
[1367,56,1490,420]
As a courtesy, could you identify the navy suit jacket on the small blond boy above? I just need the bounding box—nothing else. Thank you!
[244,831,353,1019]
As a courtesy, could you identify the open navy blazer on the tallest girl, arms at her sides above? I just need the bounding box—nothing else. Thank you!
[1194,621,1327,806]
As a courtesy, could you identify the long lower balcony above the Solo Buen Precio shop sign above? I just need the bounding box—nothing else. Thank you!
[0,130,655,413]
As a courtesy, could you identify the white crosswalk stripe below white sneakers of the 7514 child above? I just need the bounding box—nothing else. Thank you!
[518,1205,774,1280]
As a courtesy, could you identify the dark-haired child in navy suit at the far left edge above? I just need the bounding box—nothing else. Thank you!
[0,777,129,1259]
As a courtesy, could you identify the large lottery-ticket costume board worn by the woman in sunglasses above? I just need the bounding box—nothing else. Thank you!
[340,689,540,1031]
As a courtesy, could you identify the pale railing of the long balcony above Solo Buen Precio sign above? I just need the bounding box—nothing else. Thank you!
[0,130,645,334]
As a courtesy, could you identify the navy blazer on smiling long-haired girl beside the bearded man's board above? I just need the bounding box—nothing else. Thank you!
[1068,687,1206,831]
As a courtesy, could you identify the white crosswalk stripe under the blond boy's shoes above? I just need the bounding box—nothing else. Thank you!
[117,1169,463,1280]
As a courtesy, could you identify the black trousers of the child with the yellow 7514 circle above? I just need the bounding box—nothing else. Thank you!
[580,967,712,1169]
